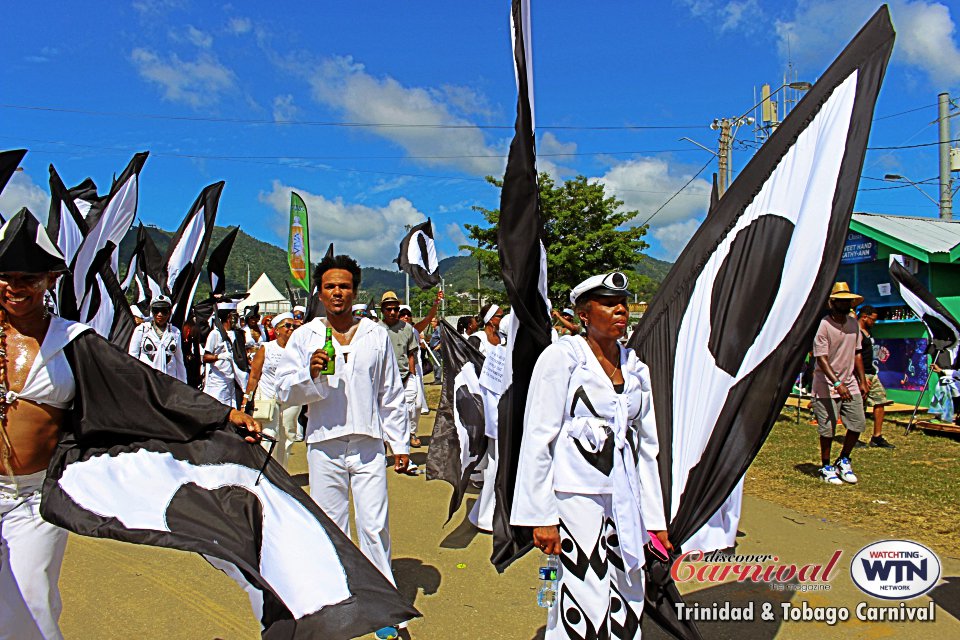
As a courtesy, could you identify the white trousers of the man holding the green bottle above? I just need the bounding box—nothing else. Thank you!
[307,435,396,584]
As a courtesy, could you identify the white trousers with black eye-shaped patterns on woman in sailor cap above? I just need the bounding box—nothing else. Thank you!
[544,491,644,640]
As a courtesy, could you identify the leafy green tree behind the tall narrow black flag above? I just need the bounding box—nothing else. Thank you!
[460,173,649,306]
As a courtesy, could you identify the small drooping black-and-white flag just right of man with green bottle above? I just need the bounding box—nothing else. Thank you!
[427,320,488,520]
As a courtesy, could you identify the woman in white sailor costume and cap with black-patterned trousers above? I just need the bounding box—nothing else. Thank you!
[511,272,672,640]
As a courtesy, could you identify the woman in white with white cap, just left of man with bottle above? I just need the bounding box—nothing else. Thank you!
[243,312,300,466]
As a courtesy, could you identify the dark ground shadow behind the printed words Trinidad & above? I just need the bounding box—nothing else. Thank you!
[643,582,797,640]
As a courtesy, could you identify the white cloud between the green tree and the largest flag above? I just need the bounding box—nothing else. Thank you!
[598,157,711,227]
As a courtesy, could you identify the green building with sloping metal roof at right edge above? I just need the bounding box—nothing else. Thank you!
[837,213,960,405]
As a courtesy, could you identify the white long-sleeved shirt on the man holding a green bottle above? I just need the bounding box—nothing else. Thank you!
[277,318,410,454]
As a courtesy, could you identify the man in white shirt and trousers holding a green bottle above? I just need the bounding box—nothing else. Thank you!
[277,255,410,596]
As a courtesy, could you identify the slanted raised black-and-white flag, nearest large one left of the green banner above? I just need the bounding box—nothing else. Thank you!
[167,181,224,328]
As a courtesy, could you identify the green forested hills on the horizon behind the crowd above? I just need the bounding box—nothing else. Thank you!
[120,226,673,301]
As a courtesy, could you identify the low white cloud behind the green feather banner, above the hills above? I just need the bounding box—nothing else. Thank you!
[259,180,427,268]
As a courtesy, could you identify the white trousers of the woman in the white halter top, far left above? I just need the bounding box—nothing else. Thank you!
[0,471,67,640]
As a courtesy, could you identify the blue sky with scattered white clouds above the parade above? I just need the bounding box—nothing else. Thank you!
[0,0,960,266]
